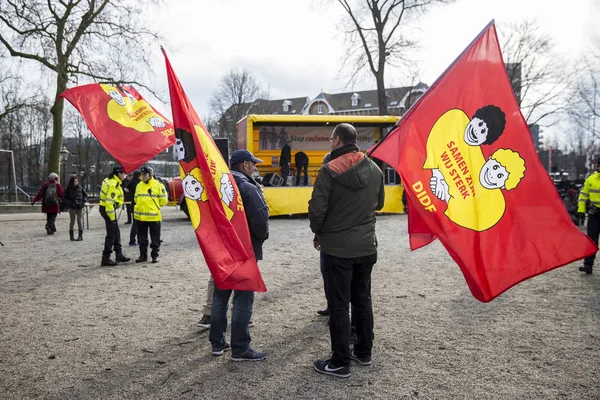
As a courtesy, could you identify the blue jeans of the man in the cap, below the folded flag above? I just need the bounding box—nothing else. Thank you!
[208,286,254,355]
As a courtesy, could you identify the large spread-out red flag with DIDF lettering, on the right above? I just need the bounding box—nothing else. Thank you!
[372,21,597,302]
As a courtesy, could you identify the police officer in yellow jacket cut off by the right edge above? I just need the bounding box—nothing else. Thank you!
[577,159,600,274]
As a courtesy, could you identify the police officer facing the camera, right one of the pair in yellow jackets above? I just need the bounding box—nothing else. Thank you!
[133,167,168,263]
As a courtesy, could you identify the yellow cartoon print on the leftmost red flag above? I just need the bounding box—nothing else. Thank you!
[100,84,167,132]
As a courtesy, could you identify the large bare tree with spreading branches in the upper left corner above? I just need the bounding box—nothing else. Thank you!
[0,0,162,177]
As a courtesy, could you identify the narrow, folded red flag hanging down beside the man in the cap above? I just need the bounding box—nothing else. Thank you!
[163,50,267,292]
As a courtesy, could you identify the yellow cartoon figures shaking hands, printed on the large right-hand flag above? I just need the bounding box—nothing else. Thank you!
[423,105,526,231]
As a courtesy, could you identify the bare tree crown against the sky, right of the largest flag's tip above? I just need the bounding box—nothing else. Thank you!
[499,20,575,126]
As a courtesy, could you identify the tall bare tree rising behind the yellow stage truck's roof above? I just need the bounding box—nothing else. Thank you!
[336,0,452,115]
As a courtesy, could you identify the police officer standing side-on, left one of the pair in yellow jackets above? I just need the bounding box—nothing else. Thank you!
[100,166,130,266]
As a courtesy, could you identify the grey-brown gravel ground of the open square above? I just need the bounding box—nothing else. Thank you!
[0,208,600,400]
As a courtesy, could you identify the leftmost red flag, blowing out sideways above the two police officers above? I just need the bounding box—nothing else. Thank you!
[61,83,175,172]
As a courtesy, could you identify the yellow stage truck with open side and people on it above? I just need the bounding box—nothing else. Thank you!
[237,115,404,215]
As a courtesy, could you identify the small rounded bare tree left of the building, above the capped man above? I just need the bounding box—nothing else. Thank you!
[209,69,261,151]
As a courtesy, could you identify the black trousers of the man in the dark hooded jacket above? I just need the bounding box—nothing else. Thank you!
[323,253,377,367]
